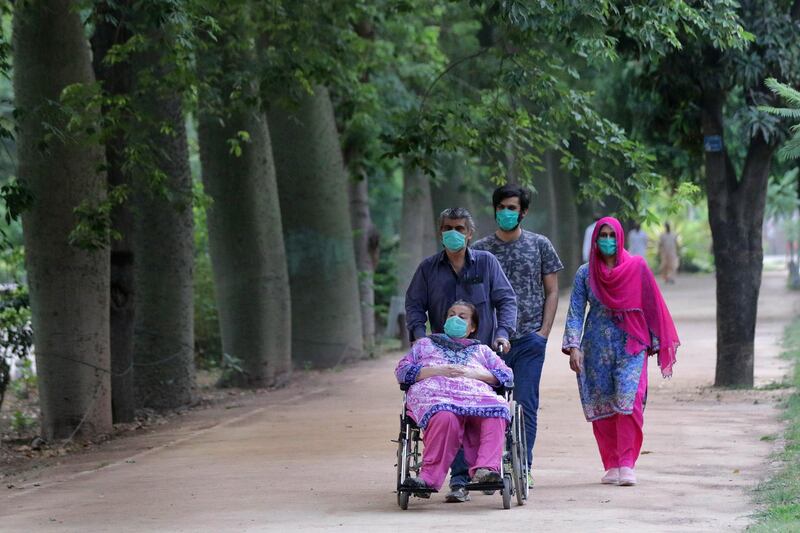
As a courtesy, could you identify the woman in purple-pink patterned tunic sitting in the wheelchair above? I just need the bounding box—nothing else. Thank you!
[395,300,513,490]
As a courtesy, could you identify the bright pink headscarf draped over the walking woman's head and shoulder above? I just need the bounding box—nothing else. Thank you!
[589,217,681,377]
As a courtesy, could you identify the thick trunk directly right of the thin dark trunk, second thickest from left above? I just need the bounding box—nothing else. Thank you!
[133,23,196,409]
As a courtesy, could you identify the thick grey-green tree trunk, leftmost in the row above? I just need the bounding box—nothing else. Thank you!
[13,0,111,439]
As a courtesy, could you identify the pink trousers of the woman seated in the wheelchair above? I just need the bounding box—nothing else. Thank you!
[419,411,506,490]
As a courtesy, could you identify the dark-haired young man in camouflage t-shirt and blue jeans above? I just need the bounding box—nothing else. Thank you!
[473,184,564,484]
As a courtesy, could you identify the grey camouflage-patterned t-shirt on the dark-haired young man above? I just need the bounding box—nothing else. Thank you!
[472,230,564,337]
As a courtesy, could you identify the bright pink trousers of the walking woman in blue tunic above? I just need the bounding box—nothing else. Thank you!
[592,357,647,470]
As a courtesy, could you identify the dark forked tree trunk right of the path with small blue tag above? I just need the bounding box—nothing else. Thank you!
[703,92,775,387]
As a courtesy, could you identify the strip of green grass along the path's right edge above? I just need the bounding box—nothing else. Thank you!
[748,318,800,532]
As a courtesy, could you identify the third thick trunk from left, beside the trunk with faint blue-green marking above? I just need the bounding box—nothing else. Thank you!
[199,104,292,387]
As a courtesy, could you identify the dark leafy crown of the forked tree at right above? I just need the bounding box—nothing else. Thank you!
[619,0,800,182]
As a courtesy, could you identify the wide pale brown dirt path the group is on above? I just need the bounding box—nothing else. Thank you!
[0,273,800,532]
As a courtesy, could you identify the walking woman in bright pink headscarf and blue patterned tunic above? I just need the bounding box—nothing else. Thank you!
[561,217,680,486]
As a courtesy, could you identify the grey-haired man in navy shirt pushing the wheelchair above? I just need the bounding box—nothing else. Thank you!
[406,207,517,502]
